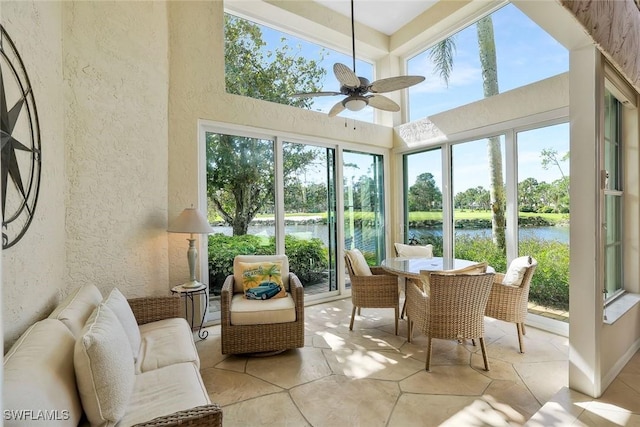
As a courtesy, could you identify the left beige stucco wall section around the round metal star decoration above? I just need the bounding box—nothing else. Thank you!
[0,2,68,351]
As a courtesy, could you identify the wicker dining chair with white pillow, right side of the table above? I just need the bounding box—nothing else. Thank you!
[485,256,538,353]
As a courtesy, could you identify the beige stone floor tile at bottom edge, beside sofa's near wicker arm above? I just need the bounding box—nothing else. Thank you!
[222,392,310,427]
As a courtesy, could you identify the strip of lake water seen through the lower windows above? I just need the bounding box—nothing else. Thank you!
[206,224,569,245]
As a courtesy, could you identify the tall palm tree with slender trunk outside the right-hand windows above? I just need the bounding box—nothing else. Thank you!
[429,16,506,250]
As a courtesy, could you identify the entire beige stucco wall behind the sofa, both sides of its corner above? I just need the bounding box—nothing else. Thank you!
[2,2,169,348]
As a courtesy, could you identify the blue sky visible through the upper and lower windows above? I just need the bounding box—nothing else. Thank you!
[234,4,569,192]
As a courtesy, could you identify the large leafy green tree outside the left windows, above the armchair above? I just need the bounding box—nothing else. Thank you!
[207,15,326,235]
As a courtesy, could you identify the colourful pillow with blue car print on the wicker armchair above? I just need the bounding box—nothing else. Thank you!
[237,261,287,300]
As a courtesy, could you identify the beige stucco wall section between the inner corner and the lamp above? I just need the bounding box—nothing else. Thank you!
[63,2,169,297]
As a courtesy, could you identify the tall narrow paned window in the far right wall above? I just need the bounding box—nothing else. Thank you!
[601,90,624,300]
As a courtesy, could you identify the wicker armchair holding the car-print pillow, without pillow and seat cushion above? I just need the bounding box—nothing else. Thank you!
[220,255,304,354]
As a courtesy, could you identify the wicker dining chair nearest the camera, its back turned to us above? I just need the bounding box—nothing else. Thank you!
[407,272,494,371]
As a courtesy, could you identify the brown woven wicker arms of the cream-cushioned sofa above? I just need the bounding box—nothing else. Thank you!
[127,295,222,427]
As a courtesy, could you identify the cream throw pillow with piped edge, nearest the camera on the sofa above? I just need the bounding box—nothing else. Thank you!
[73,303,135,426]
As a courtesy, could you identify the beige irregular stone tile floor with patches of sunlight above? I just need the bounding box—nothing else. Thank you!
[196,299,640,427]
